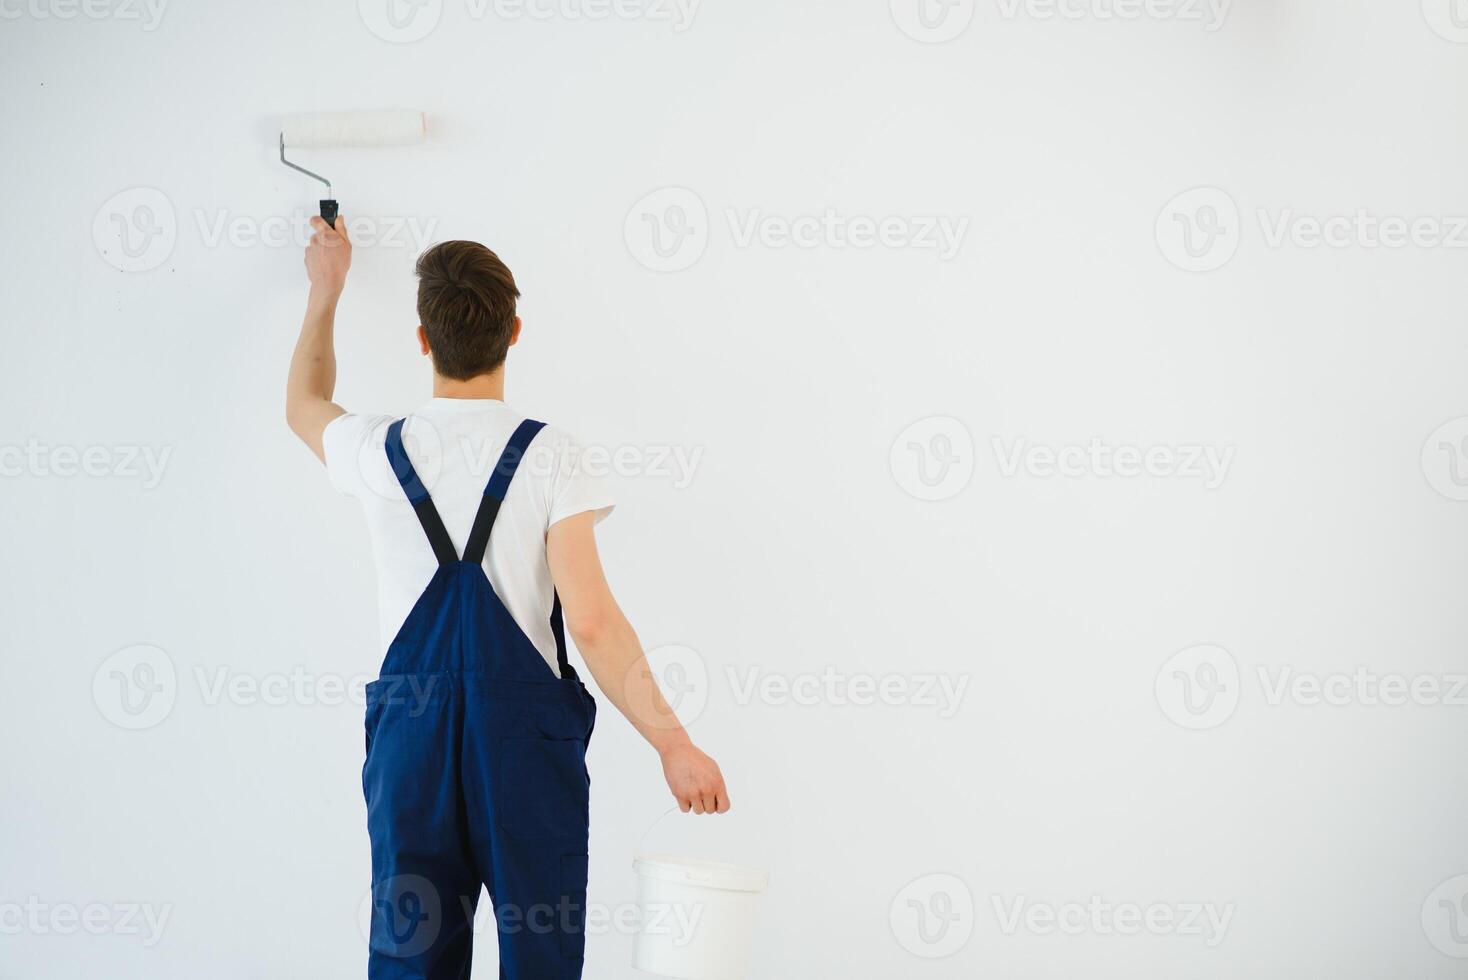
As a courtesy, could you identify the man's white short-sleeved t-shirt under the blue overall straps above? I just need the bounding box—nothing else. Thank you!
[321,398,612,670]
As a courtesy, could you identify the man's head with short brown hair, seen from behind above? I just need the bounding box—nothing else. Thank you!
[417,242,520,381]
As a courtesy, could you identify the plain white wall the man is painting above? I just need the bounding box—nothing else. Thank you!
[0,0,1468,980]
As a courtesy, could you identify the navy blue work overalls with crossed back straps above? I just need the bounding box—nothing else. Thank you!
[363,420,596,980]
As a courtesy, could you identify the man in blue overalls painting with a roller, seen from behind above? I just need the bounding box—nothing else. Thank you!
[286,219,730,980]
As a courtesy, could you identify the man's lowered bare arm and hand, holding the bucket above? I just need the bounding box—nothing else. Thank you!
[546,511,730,813]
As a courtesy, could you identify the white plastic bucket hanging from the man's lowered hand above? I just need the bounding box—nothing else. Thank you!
[633,854,769,980]
